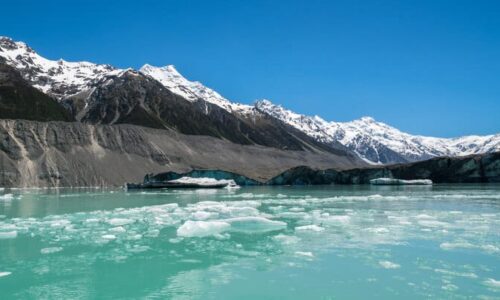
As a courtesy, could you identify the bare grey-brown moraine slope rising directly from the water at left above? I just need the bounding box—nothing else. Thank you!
[0,120,357,187]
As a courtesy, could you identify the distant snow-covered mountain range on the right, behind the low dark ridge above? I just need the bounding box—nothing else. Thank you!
[255,100,500,164]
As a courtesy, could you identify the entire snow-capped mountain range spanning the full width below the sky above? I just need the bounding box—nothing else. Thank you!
[0,37,500,164]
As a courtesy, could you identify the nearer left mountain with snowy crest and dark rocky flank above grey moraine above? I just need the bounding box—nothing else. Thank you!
[0,38,359,160]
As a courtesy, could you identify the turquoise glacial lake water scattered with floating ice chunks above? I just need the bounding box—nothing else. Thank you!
[0,185,500,299]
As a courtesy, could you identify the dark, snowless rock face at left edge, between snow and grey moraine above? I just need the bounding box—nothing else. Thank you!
[0,61,72,121]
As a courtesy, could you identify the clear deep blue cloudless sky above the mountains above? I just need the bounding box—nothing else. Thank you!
[0,0,500,137]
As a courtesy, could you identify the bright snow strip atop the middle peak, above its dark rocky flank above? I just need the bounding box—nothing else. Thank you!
[140,64,252,113]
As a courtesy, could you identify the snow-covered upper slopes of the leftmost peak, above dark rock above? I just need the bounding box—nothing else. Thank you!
[0,37,121,99]
